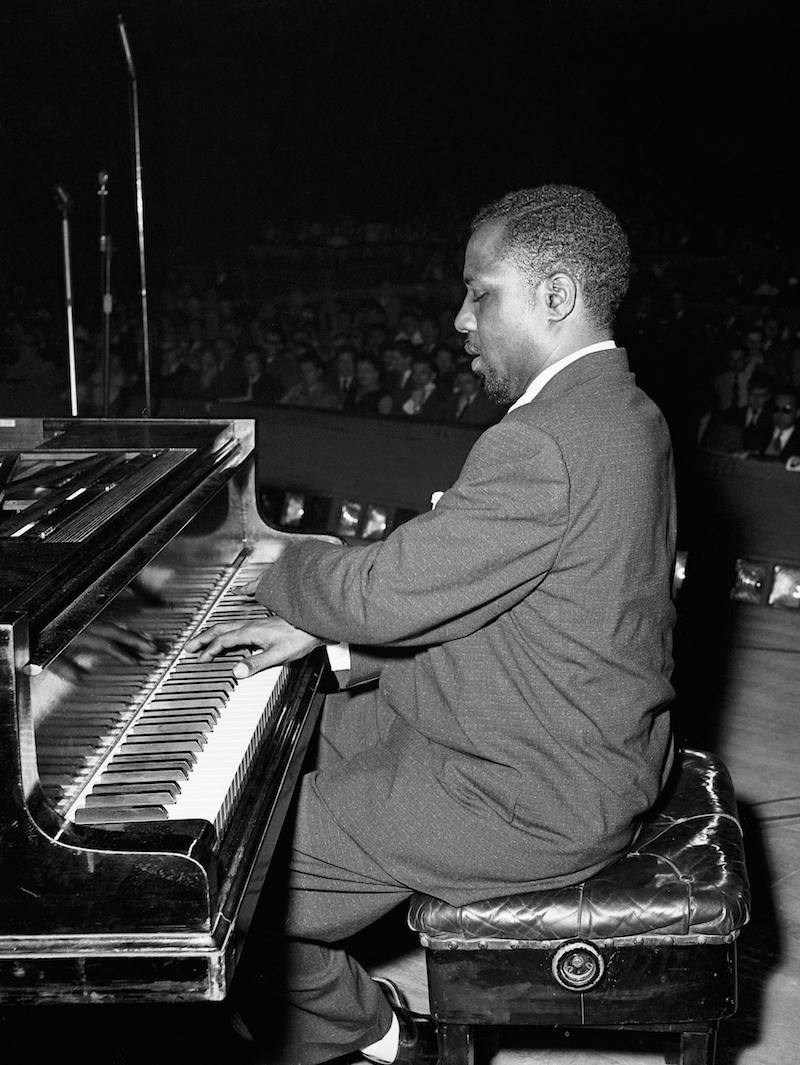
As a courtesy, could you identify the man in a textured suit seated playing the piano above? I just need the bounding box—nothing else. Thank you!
[193,185,675,1065]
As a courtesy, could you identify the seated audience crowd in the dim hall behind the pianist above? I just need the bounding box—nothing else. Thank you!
[0,207,800,464]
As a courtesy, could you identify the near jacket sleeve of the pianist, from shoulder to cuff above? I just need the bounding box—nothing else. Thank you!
[257,415,569,648]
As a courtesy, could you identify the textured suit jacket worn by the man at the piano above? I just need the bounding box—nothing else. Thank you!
[257,348,675,904]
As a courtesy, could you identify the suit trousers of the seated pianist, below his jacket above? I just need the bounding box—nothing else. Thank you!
[233,690,411,1065]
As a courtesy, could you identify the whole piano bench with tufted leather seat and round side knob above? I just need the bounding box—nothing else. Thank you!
[408,750,750,1065]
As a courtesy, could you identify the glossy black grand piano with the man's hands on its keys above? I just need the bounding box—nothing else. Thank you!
[0,419,325,1003]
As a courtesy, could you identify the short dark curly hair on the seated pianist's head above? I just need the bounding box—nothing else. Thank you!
[471,185,631,326]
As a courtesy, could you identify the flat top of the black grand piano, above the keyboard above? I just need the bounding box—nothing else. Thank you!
[0,419,255,665]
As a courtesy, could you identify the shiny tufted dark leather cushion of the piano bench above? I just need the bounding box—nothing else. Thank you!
[408,751,750,950]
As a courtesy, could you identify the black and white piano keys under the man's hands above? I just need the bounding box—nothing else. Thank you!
[55,568,288,834]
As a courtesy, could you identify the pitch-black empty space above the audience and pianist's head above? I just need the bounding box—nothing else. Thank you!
[0,0,798,297]
